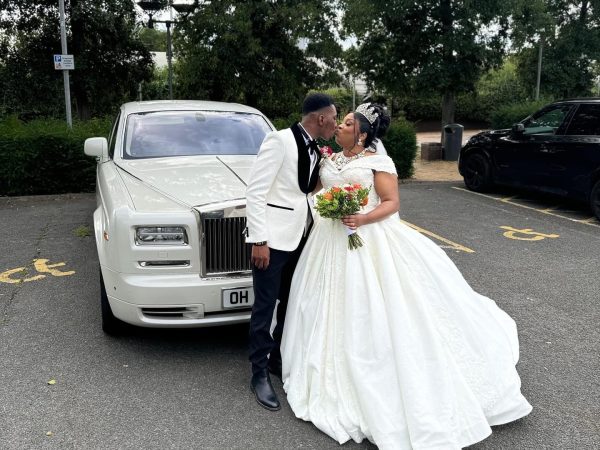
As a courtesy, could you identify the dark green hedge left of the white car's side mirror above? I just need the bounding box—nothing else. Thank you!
[0,117,110,195]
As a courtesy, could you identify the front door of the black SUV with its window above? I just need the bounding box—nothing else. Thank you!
[494,103,574,190]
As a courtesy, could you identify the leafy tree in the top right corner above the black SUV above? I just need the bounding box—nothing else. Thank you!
[512,0,600,98]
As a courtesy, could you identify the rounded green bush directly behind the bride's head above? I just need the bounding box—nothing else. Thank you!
[382,119,417,179]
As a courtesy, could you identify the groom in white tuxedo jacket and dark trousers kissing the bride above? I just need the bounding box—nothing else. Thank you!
[246,93,337,411]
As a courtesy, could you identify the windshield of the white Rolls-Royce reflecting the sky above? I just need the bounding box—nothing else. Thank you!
[123,111,271,159]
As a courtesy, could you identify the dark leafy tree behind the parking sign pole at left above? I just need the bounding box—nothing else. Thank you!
[0,0,152,119]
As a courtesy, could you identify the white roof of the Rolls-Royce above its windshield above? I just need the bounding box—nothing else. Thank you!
[121,100,262,115]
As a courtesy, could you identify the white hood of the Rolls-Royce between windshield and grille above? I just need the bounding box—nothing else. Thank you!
[117,155,256,208]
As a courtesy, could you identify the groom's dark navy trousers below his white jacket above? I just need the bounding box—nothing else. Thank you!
[249,236,307,373]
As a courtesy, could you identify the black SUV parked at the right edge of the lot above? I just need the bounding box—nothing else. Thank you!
[458,98,600,219]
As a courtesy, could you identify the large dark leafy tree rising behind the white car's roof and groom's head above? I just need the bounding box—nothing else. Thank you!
[174,0,341,117]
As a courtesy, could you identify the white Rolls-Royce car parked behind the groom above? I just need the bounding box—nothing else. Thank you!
[85,101,274,334]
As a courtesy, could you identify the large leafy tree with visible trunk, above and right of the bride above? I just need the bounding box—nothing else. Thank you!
[343,0,512,124]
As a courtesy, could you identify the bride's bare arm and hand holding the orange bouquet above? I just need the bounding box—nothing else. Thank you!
[342,172,400,229]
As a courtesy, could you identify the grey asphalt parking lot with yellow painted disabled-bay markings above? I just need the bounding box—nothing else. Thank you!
[0,183,600,450]
